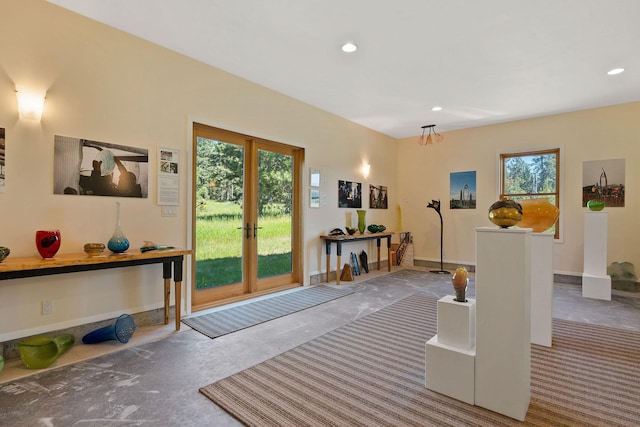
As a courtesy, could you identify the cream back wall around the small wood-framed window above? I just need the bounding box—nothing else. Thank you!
[398,103,640,275]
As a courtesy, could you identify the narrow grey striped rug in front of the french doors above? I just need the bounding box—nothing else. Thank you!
[182,286,353,338]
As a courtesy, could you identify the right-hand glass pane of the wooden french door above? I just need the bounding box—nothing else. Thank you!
[257,150,293,279]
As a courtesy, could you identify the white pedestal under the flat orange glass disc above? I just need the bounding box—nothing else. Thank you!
[531,233,553,347]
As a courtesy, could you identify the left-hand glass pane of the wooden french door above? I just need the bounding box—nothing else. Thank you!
[195,137,245,289]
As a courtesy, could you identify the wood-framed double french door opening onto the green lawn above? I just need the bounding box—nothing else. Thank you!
[191,124,304,311]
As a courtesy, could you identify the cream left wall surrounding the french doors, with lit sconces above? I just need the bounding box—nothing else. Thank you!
[0,0,397,342]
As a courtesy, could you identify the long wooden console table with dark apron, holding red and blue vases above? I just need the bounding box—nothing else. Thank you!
[0,249,192,331]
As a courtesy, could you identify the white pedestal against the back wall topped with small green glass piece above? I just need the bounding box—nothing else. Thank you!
[582,211,611,301]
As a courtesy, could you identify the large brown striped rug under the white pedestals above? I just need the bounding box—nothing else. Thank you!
[200,295,640,427]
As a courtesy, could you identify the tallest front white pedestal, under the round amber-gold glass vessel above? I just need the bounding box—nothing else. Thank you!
[474,227,531,421]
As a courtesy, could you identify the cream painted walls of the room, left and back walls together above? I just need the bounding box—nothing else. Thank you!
[0,0,640,342]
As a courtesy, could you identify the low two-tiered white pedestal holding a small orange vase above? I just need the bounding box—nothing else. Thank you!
[425,295,476,405]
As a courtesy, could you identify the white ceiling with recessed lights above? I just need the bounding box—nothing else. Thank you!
[49,0,640,138]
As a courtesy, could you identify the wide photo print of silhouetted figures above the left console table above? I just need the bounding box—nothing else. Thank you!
[53,135,149,198]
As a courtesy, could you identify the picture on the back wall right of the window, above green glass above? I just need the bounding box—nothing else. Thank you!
[582,159,625,208]
